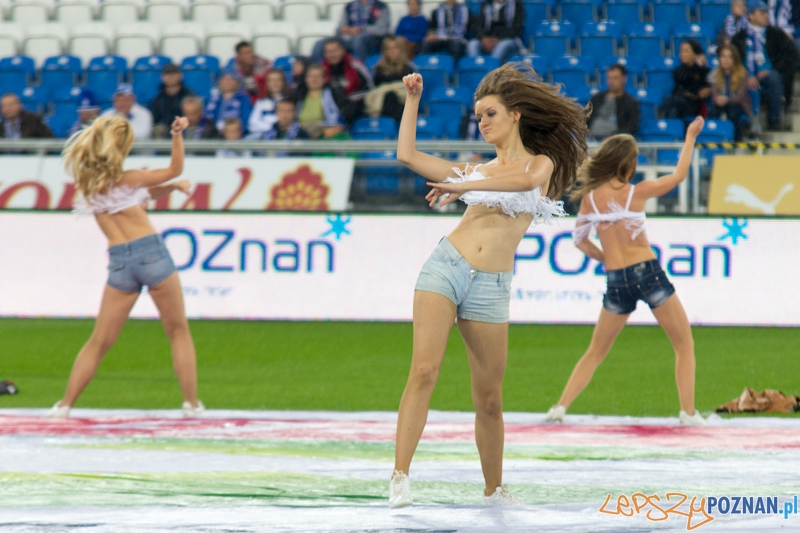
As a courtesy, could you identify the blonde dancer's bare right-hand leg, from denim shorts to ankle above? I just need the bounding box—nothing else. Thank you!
[150,272,197,407]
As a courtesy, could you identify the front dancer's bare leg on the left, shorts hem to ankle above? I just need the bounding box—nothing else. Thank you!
[394,291,456,474]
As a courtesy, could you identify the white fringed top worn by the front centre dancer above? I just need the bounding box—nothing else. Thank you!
[444,159,567,224]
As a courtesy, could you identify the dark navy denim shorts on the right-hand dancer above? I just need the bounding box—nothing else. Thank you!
[603,259,675,315]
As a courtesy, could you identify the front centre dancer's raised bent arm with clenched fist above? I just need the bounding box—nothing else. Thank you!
[397,73,466,182]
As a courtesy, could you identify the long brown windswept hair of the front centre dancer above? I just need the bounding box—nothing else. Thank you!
[475,63,591,200]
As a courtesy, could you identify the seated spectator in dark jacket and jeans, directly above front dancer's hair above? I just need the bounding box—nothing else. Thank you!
[467,0,525,63]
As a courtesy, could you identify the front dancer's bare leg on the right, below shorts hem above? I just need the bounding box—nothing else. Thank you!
[458,319,508,496]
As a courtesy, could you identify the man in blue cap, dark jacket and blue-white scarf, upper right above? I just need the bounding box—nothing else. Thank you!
[731,1,800,130]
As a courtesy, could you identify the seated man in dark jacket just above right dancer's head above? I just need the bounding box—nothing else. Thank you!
[586,64,640,140]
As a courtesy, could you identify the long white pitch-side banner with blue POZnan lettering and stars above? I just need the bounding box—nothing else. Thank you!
[0,211,800,326]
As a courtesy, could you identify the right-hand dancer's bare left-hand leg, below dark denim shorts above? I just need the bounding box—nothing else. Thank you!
[558,309,630,409]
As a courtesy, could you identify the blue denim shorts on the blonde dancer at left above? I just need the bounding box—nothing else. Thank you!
[106,234,175,292]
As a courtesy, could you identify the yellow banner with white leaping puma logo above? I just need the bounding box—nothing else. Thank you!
[708,155,800,215]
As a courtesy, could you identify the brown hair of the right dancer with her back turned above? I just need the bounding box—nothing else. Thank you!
[569,133,639,202]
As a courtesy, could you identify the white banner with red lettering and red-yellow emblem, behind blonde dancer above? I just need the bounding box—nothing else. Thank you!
[0,156,355,211]
